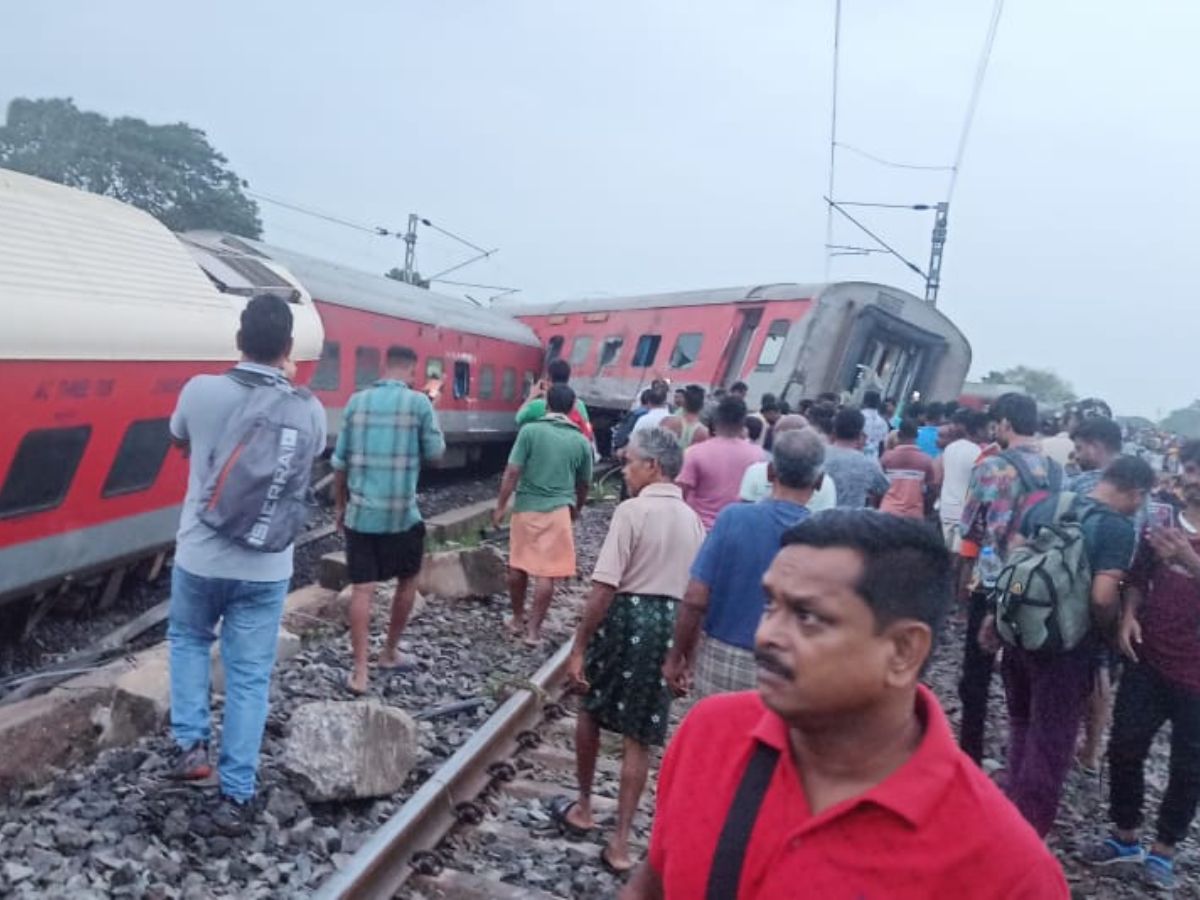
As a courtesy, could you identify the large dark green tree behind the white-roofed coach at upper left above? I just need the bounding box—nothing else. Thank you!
[0,97,263,238]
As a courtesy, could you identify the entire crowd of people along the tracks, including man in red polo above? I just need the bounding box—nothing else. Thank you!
[162,298,1200,898]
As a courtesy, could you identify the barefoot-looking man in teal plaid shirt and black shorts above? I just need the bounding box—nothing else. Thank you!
[332,347,446,694]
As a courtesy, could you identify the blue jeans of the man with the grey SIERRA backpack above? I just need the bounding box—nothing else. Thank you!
[167,565,288,800]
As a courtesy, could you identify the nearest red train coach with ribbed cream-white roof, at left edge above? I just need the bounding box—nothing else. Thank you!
[0,169,322,602]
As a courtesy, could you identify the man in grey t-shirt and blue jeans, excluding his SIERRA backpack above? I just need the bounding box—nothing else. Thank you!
[167,295,325,833]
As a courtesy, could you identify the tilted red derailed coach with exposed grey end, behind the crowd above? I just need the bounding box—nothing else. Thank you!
[505,282,971,422]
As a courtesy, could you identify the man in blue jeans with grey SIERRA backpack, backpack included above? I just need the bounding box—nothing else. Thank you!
[167,294,325,833]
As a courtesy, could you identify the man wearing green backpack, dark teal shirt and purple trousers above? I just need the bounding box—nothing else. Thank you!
[984,456,1154,836]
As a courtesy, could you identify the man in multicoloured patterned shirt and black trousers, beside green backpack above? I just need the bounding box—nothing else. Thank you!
[958,394,1063,763]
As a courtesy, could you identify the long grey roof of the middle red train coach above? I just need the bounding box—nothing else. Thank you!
[184,232,540,347]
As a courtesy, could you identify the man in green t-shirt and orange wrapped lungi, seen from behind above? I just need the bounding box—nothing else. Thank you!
[492,384,592,646]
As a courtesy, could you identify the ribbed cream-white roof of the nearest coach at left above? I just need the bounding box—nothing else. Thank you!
[0,169,298,360]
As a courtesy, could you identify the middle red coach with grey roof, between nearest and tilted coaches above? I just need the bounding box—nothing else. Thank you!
[184,232,542,467]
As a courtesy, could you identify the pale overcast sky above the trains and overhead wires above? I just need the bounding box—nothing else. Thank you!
[0,0,1200,415]
